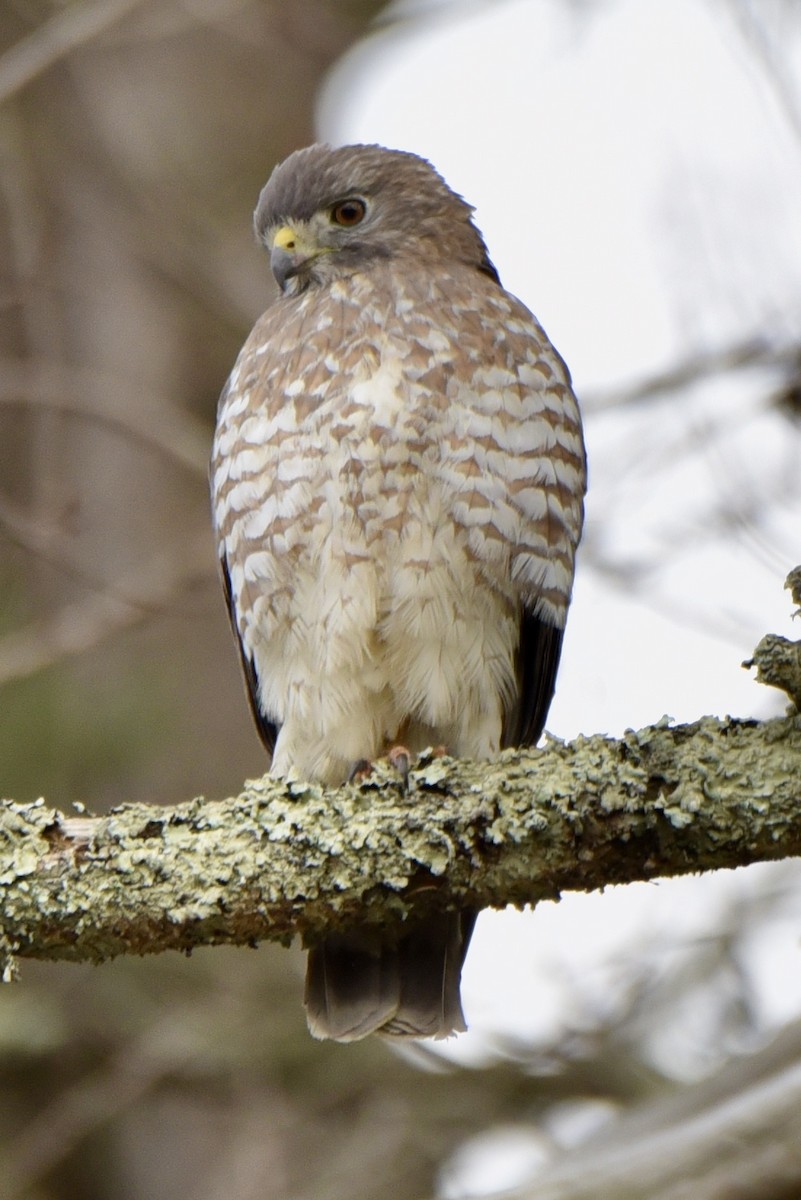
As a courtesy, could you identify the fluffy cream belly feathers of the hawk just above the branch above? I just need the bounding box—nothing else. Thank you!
[243,476,517,782]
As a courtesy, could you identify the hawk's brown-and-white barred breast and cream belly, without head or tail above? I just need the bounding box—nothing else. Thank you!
[213,258,584,776]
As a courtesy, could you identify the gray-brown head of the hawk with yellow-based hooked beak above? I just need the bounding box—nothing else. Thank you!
[254,144,498,295]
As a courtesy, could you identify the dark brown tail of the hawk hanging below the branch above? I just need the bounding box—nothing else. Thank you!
[306,910,476,1042]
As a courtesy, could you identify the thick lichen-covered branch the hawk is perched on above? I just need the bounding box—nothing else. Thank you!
[0,715,801,973]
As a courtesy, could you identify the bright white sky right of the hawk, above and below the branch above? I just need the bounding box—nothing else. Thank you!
[319,0,801,1187]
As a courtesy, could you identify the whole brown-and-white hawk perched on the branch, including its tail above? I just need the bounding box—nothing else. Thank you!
[212,145,585,1042]
